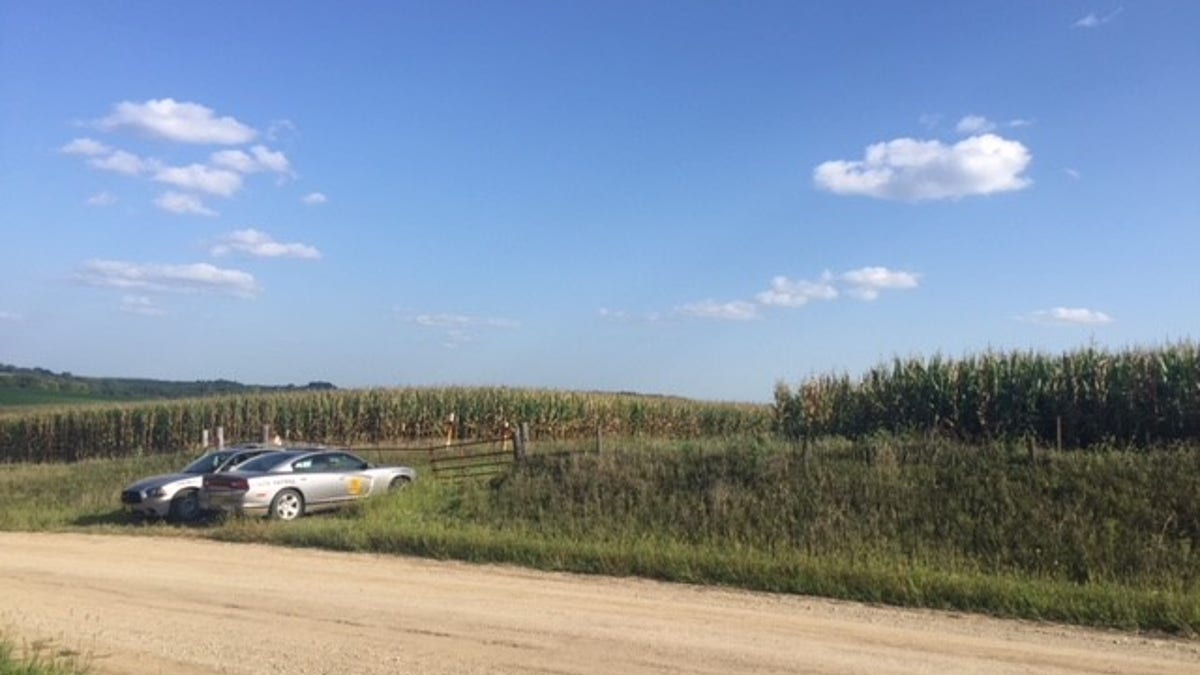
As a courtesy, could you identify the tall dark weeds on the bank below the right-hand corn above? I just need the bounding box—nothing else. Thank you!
[470,437,1200,592]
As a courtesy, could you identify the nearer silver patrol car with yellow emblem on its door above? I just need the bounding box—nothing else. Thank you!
[200,449,416,520]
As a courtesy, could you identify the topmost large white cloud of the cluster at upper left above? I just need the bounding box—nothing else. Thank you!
[97,98,257,145]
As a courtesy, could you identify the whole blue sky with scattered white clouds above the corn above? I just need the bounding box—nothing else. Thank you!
[0,0,1200,401]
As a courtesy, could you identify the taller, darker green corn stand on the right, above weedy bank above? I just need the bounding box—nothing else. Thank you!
[775,342,1200,448]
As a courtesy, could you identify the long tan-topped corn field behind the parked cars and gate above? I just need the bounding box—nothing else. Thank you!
[0,388,772,461]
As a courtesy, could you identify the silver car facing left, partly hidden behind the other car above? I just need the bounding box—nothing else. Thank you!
[121,443,272,522]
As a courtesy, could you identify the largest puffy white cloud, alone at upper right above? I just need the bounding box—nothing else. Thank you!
[812,133,1031,201]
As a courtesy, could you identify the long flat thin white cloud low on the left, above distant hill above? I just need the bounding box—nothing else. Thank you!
[76,261,258,298]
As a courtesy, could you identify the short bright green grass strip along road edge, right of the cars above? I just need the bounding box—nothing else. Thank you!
[206,466,1200,637]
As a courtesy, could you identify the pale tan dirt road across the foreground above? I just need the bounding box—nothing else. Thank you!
[0,533,1200,675]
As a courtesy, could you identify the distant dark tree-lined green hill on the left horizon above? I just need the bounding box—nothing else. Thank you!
[0,364,337,407]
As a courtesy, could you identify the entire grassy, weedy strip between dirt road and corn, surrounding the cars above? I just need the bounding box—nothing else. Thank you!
[0,436,1200,634]
